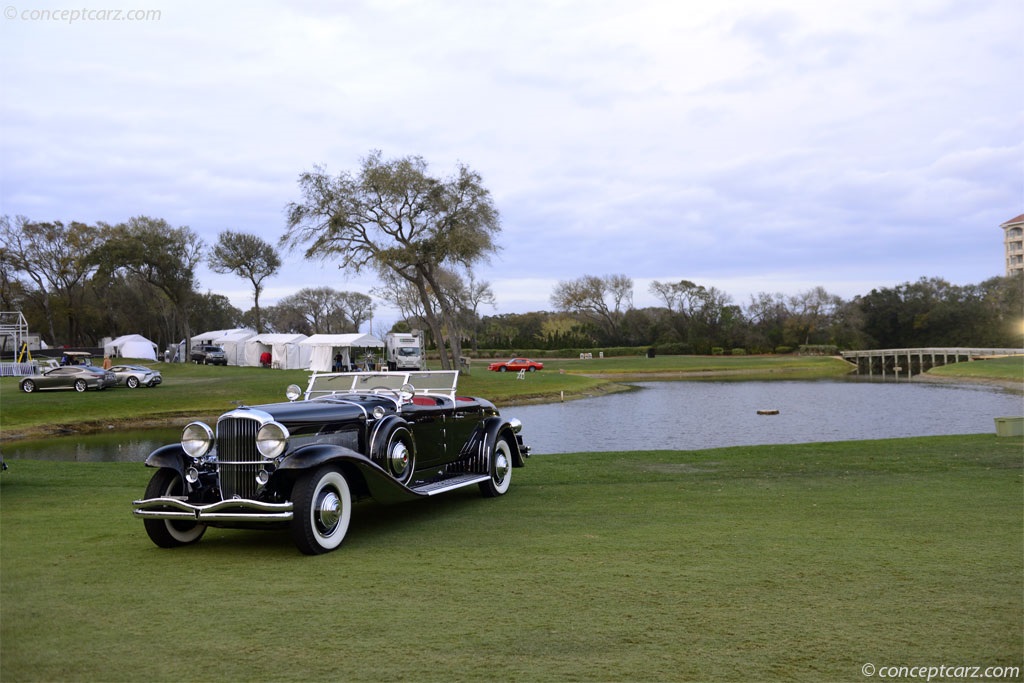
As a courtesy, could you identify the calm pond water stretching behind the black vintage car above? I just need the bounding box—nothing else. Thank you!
[3,380,1024,462]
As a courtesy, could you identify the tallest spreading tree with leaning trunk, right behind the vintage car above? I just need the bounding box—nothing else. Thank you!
[282,152,500,369]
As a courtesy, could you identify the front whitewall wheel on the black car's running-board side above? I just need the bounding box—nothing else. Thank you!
[291,465,352,555]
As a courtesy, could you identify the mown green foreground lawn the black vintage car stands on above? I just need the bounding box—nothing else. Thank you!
[0,435,1024,682]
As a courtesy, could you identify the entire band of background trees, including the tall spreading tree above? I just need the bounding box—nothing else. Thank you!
[0,152,1024,360]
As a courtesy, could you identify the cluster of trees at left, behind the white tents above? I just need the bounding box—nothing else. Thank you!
[0,216,374,353]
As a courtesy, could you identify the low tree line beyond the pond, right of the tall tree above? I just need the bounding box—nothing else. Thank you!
[481,273,1024,354]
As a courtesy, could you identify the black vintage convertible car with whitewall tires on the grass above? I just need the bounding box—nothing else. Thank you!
[133,371,529,555]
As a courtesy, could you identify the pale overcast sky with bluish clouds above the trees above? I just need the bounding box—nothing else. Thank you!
[0,0,1024,330]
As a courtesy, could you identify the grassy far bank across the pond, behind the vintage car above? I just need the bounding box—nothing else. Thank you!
[0,356,849,440]
